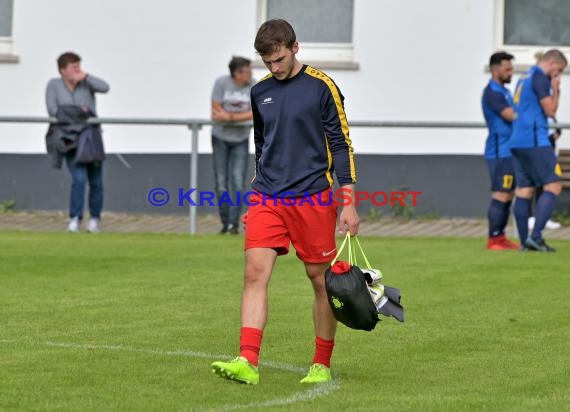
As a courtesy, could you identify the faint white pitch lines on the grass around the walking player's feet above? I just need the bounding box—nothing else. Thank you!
[0,339,340,412]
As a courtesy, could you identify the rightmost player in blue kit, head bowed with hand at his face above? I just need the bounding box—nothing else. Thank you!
[511,49,568,252]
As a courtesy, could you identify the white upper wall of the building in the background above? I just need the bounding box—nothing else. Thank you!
[0,0,570,154]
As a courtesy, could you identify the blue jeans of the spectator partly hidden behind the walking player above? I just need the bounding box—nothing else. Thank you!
[212,136,249,227]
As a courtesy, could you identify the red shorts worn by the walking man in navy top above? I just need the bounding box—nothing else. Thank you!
[245,189,337,263]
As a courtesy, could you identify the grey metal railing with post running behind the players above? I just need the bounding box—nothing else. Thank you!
[0,116,570,234]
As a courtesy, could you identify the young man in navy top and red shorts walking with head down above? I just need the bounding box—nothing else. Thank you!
[212,19,359,384]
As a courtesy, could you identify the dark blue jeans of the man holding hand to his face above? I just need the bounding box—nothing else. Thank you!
[65,150,103,220]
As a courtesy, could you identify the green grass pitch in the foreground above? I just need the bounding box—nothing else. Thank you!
[0,232,570,412]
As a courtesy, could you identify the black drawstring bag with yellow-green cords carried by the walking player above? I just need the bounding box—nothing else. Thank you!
[325,234,404,331]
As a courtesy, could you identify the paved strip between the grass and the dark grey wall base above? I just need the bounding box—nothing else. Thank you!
[0,211,570,239]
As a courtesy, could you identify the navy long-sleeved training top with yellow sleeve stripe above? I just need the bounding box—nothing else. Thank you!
[251,66,356,197]
